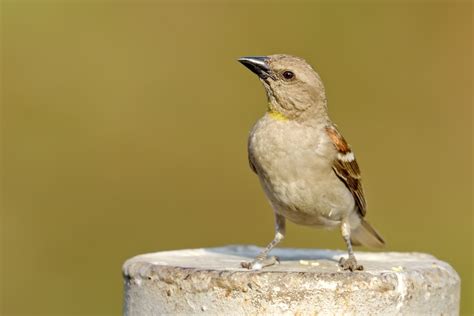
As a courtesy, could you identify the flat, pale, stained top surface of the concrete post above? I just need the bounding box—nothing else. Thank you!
[123,246,452,275]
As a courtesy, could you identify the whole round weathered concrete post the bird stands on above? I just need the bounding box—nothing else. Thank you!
[123,246,460,315]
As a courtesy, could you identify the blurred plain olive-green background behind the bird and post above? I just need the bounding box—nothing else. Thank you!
[0,0,474,315]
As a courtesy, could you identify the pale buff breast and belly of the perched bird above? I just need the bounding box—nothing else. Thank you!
[249,117,354,226]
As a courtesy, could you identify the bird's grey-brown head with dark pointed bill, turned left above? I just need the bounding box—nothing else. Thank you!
[238,54,327,119]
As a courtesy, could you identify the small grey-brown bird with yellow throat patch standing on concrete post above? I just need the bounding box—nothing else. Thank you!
[238,54,385,271]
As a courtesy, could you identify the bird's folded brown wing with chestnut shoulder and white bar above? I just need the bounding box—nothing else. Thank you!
[326,126,367,217]
